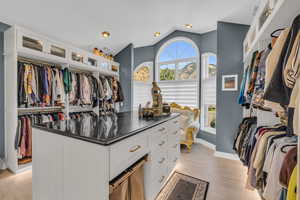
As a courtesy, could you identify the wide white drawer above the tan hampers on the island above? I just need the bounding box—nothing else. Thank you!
[110,133,149,180]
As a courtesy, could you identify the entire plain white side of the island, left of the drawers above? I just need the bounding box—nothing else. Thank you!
[32,129,109,200]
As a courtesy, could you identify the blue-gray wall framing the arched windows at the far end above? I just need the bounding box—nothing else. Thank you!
[134,31,217,144]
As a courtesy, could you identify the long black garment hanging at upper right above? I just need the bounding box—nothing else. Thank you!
[264,15,300,106]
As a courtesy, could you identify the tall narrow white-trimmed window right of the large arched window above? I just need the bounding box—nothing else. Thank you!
[201,53,217,134]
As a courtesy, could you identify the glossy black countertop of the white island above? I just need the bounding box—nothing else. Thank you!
[33,112,180,145]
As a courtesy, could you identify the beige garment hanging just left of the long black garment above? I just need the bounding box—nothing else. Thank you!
[264,28,290,112]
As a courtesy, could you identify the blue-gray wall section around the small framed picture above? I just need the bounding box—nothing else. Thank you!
[216,22,249,153]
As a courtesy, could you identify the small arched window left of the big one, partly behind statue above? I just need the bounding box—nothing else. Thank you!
[133,62,153,110]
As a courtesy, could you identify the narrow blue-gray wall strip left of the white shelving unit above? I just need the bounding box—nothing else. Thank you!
[0,22,9,159]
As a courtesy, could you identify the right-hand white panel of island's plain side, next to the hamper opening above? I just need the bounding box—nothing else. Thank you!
[64,138,109,200]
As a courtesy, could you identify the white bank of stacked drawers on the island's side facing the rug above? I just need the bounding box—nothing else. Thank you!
[145,119,180,200]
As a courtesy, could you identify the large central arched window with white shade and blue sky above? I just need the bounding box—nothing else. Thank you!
[155,37,199,107]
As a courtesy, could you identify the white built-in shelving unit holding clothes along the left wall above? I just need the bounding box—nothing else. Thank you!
[4,26,119,173]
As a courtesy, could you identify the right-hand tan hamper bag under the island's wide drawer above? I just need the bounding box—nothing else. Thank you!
[129,166,145,200]
